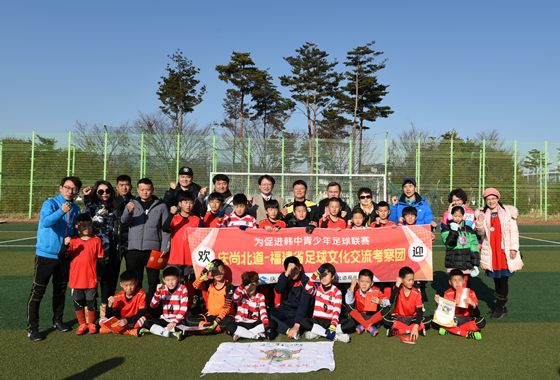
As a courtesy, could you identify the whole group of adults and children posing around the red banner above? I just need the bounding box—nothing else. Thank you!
[27,167,523,342]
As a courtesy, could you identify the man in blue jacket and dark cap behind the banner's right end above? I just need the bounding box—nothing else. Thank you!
[389,178,437,228]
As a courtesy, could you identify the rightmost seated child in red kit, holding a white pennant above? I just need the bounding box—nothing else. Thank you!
[434,269,486,340]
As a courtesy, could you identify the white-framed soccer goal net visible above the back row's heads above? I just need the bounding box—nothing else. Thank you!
[208,172,390,207]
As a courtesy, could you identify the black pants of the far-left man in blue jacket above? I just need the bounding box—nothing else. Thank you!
[27,256,70,331]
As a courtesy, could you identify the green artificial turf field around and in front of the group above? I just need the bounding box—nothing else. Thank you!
[0,223,560,380]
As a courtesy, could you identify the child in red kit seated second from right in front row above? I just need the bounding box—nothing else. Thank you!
[383,267,431,340]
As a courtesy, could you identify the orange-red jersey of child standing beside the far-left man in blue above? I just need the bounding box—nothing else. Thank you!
[66,237,105,289]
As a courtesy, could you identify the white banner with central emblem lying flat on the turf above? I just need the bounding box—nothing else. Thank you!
[202,342,335,374]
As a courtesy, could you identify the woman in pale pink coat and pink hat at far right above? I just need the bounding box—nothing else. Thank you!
[475,187,523,320]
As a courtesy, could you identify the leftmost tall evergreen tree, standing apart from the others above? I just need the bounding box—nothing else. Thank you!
[156,49,206,132]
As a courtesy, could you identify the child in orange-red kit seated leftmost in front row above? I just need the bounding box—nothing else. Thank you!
[99,270,149,336]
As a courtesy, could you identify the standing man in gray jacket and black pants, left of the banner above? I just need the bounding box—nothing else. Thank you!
[121,178,171,304]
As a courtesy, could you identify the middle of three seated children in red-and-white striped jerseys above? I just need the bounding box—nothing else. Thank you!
[226,270,278,340]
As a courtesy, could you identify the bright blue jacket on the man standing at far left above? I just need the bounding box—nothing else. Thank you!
[36,194,80,259]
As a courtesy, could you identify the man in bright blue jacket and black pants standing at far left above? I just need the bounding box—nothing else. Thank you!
[27,177,82,342]
